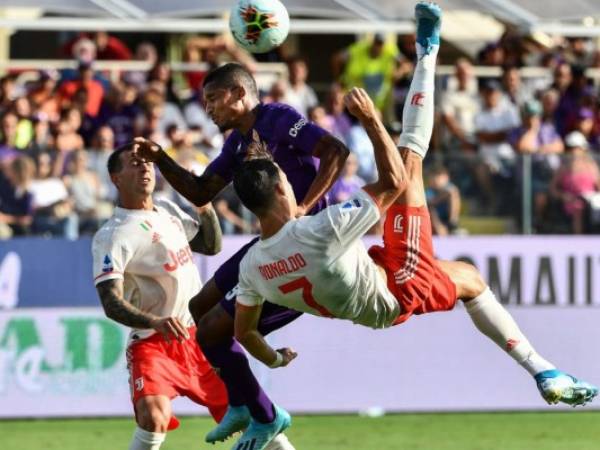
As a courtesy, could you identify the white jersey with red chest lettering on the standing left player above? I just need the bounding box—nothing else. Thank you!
[92,199,202,339]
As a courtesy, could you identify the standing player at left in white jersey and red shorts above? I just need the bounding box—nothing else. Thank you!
[92,143,294,450]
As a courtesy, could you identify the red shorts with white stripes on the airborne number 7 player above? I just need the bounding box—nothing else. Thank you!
[369,204,456,325]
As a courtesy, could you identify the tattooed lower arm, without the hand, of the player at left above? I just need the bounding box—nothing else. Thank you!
[96,280,157,328]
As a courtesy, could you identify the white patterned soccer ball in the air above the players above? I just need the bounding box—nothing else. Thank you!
[229,0,290,53]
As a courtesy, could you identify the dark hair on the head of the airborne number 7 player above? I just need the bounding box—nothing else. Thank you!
[233,158,280,216]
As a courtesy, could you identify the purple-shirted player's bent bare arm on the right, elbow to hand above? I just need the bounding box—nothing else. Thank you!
[296,134,350,217]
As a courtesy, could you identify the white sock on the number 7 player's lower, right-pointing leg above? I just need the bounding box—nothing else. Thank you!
[465,287,556,375]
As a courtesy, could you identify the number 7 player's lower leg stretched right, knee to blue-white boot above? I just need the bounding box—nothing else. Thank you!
[433,261,598,406]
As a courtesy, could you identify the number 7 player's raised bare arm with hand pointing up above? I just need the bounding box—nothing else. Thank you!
[344,88,407,212]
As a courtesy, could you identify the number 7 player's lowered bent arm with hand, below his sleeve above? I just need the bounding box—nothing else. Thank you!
[235,303,297,369]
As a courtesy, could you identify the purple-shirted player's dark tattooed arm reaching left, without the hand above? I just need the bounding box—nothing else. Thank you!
[156,153,227,206]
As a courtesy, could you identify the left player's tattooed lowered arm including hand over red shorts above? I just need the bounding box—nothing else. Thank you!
[96,279,189,340]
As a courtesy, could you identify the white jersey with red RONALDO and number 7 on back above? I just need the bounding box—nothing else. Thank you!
[237,190,400,328]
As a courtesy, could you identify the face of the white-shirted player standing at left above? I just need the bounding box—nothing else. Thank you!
[113,152,156,197]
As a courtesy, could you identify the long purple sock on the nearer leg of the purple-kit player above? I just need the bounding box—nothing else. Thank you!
[202,338,275,423]
